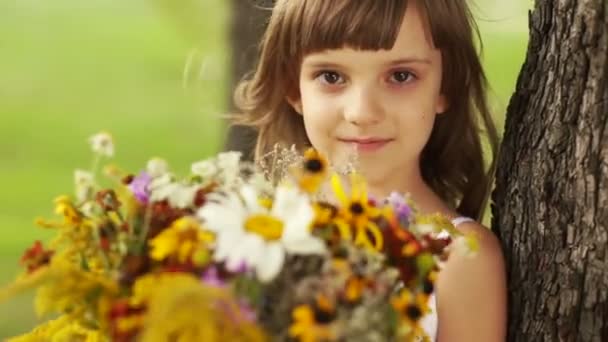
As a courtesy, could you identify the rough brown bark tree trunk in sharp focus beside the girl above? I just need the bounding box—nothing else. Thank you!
[492,0,608,342]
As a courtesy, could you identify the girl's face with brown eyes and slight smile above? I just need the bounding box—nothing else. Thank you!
[289,1,446,186]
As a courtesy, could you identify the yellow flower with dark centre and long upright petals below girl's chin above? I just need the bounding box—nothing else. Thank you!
[331,173,383,251]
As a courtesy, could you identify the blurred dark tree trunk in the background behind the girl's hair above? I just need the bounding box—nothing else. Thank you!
[225,0,273,159]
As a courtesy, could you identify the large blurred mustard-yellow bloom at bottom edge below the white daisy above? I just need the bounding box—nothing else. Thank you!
[134,273,266,342]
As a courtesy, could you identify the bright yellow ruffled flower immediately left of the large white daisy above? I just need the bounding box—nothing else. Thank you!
[149,216,213,264]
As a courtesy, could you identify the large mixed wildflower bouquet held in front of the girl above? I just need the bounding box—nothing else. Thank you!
[0,133,475,341]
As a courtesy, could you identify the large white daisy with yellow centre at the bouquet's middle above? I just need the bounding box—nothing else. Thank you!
[198,186,326,282]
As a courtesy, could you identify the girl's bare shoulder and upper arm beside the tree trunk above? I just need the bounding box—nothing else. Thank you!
[437,220,507,341]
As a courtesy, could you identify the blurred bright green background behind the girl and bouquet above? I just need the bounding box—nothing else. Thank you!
[0,0,530,339]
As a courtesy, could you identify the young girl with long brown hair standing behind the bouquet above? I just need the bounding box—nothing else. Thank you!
[235,0,506,342]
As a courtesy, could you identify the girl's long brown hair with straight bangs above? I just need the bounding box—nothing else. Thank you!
[235,0,498,219]
